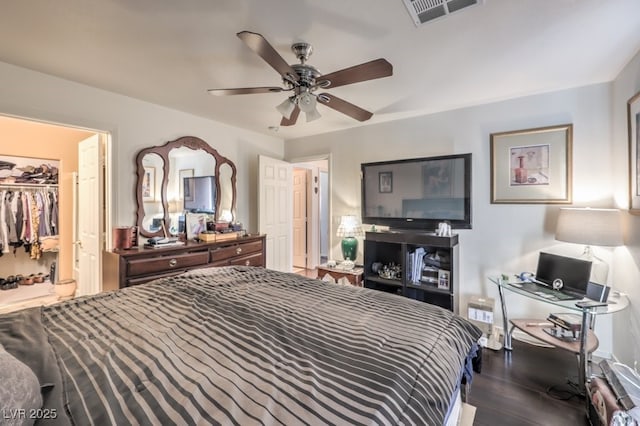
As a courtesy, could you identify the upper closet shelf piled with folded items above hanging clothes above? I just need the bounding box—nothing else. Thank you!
[0,155,60,185]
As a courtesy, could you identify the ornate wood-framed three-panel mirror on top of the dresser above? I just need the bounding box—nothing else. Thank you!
[136,136,236,238]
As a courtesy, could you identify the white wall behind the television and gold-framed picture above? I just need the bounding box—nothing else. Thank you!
[285,84,632,353]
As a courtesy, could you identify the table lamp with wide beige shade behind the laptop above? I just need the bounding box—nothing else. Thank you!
[556,208,624,285]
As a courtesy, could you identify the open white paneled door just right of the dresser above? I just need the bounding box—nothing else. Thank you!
[258,155,293,272]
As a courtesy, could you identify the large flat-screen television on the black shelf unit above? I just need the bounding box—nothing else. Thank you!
[361,154,471,231]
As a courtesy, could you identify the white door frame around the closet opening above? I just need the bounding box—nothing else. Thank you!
[0,110,115,287]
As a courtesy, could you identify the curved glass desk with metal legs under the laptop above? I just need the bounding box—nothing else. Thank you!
[489,274,629,391]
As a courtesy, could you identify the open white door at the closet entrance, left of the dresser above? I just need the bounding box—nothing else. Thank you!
[74,134,104,296]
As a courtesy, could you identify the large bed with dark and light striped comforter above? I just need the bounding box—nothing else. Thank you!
[0,266,481,425]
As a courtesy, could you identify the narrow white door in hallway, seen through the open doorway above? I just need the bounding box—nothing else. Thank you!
[293,168,307,268]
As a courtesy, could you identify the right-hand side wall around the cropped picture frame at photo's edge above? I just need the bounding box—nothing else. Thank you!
[612,52,640,366]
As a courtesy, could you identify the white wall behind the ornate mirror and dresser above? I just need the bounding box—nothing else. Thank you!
[0,62,284,232]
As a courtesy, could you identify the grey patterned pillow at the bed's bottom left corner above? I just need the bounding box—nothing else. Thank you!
[0,345,42,426]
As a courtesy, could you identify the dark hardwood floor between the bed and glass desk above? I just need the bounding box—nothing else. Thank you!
[467,340,589,426]
